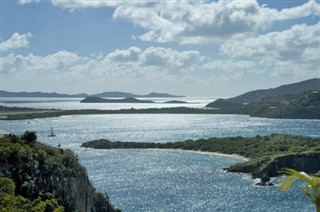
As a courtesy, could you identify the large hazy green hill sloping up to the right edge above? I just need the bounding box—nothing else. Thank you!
[206,78,320,119]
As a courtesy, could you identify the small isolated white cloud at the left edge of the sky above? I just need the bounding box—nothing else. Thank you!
[0,32,32,51]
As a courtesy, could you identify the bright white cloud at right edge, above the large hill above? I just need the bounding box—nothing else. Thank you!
[220,22,320,61]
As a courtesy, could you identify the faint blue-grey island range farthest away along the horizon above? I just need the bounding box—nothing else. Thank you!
[0,90,185,98]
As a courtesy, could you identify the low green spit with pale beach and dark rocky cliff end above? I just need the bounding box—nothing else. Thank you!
[81,134,320,184]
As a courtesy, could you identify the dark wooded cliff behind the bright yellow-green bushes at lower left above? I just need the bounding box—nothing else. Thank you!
[0,132,116,212]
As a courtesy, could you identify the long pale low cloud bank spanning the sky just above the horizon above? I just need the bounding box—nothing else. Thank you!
[1,44,319,95]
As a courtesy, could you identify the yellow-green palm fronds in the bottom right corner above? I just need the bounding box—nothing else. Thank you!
[279,168,320,212]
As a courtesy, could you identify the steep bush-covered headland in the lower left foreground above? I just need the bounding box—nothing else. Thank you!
[0,131,116,212]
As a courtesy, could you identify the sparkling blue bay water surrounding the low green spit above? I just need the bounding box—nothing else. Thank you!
[0,114,320,211]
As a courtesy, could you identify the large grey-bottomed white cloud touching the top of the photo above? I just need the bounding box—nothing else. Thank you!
[113,0,320,43]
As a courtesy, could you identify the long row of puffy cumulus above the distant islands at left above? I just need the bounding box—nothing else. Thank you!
[2,47,204,77]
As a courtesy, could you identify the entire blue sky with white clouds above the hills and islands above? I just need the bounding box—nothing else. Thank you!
[0,0,320,97]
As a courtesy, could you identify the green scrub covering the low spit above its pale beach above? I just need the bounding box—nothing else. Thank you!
[82,134,320,159]
